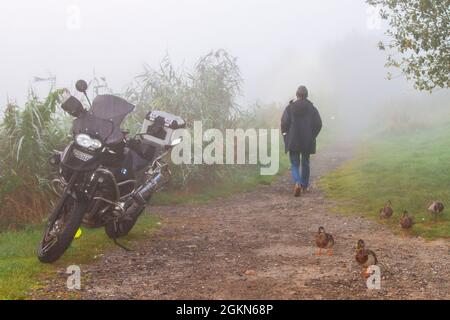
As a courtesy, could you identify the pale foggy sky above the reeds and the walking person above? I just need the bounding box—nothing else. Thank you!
[0,0,449,132]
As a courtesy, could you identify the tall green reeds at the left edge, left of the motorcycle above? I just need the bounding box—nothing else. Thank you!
[0,90,67,226]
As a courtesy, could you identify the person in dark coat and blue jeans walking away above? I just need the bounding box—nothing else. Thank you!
[281,86,322,197]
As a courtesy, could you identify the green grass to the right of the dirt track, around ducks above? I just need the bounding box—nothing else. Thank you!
[320,124,450,239]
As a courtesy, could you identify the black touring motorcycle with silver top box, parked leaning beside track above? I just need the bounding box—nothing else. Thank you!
[37,80,185,263]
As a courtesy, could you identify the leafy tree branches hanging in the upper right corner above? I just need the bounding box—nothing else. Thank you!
[367,0,450,92]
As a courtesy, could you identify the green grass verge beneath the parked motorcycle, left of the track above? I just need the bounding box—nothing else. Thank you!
[0,215,157,300]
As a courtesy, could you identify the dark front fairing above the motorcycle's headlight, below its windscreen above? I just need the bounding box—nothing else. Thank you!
[72,112,114,143]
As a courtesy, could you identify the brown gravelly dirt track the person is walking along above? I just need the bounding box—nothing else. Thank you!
[33,141,450,299]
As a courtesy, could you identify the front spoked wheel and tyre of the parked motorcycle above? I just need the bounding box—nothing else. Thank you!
[38,195,85,263]
